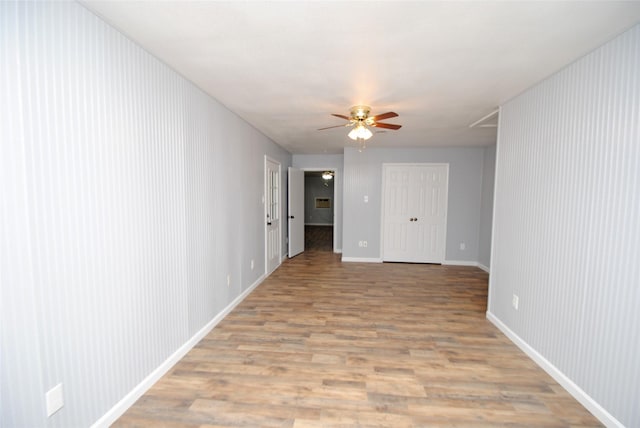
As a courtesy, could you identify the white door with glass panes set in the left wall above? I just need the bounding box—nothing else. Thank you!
[264,157,282,275]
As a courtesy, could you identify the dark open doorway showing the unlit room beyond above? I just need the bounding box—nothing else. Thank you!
[304,170,335,251]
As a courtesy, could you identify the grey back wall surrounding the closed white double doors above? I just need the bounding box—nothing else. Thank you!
[342,143,485,264]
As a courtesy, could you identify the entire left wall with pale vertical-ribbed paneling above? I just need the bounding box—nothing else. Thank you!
[0,2,291,427]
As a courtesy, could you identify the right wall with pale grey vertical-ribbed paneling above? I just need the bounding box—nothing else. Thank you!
[489,26,640,426]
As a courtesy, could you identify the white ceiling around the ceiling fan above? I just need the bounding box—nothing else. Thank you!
[83,0,640,154]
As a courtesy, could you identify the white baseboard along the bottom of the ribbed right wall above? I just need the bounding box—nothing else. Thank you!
[487,311,624,428]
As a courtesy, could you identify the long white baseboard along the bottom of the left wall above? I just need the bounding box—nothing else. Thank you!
[91,275,266,428]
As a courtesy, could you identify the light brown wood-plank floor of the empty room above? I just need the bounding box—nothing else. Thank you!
[114,251,600,428]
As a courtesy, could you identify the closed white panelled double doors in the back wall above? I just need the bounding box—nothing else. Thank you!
[382,164,449,263]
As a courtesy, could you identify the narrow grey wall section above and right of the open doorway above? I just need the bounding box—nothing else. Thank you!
[292,155,344,252]
